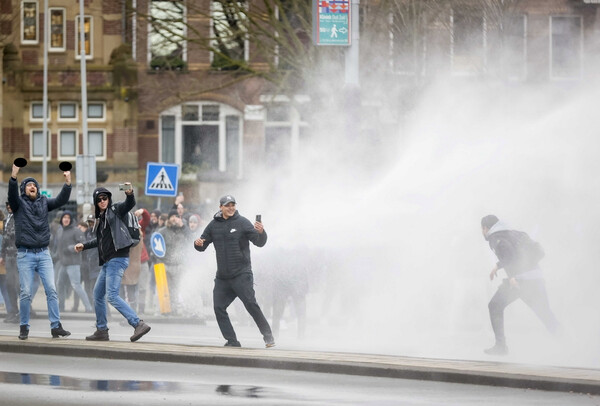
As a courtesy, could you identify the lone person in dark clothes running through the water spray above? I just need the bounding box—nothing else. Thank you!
[481,214,559,355]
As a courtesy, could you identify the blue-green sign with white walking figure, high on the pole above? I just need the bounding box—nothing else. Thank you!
[313,0,351,45]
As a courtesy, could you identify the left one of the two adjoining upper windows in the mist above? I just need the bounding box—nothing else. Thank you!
[451,10,485,74]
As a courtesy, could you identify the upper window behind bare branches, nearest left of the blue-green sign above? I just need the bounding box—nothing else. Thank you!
[211,0,249,70]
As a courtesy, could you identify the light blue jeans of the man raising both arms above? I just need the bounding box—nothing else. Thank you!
[17,248,60,328]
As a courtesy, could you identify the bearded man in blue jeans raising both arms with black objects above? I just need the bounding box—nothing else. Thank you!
[8,165,71,340]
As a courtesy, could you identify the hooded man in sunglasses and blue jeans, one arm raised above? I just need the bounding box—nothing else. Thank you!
[75,183,150,342]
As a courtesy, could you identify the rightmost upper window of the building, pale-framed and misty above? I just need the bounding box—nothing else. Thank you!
[550,16,583,79]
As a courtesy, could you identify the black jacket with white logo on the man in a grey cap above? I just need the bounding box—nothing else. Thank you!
[194,210,267,279]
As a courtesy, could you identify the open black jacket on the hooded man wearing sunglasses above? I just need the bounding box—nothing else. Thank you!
[83,188,135,265]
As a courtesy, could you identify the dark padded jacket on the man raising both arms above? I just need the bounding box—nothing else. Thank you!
[8,176,71,248]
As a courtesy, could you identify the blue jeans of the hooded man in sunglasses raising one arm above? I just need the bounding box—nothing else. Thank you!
[94,258,140,330]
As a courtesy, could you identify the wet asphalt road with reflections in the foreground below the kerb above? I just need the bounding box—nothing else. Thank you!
[0,353,600,406]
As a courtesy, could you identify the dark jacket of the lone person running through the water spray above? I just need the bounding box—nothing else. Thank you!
[486,222,538,278]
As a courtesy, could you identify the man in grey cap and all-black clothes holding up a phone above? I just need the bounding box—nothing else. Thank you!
[194,195,275,348]
